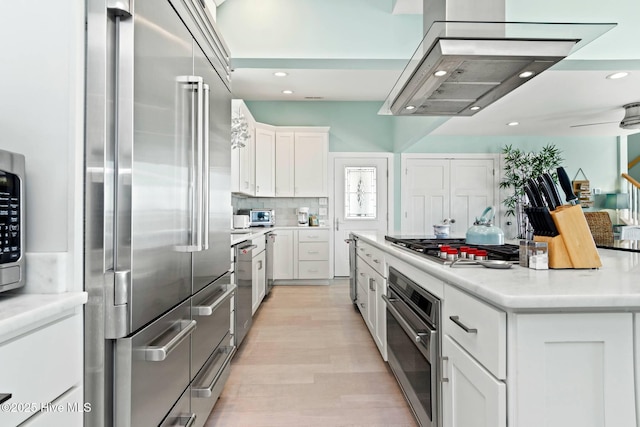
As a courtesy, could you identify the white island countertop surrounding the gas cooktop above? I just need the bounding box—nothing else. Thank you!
[358,233,640,311]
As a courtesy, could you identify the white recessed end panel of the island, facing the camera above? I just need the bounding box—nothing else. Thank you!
[509,313,638,427]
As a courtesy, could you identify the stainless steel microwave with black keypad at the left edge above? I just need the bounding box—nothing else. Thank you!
[0,150,26,292]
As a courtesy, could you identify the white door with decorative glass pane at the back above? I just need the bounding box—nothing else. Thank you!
[333,157,389,276]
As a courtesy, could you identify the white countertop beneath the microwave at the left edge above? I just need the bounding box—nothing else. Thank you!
[0,292,87,342]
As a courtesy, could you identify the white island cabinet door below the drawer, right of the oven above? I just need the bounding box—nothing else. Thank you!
[442,335,507,427]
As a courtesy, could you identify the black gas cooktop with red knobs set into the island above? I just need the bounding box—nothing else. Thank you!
[384,236,519,264]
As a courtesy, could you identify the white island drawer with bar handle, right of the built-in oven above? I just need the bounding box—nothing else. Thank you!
[442,286,507,379]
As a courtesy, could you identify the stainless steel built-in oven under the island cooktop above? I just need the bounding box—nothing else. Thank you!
[383,267,441,427]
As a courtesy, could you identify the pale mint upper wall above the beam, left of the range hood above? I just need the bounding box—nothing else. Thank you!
[217,0,422,59]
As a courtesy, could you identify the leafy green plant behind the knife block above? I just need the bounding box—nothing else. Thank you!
[500,144,563,239]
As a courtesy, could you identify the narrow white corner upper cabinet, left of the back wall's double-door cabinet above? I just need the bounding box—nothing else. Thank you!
[255,123,276,197]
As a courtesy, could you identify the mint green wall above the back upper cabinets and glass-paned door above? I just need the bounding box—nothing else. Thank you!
[245,101,393,152]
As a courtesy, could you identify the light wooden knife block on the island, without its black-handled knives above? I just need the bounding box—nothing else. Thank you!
[534,205,602,268]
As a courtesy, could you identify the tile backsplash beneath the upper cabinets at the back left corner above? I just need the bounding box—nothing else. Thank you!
[231,196,328,226]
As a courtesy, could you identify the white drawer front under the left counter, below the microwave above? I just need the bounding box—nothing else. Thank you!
[0,314,82,426]
